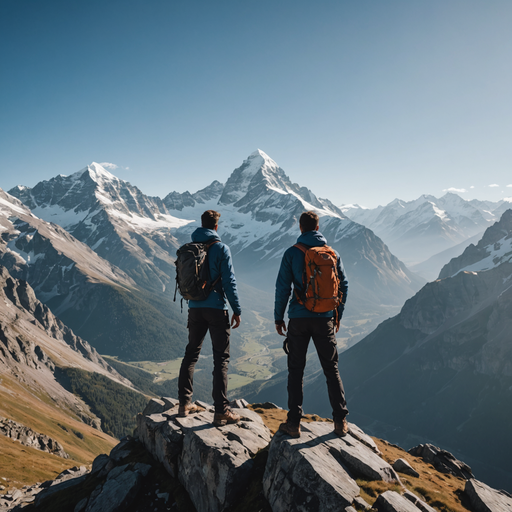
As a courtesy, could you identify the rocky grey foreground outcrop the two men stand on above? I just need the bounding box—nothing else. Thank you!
[5,398,512,512]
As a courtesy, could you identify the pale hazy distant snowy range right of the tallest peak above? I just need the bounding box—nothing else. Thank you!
[341,193,503,265]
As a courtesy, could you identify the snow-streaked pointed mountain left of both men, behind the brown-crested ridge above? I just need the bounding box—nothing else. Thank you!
[9,163,187,290]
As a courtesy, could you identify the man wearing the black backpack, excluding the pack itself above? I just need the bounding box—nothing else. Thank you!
[178,210,242,426]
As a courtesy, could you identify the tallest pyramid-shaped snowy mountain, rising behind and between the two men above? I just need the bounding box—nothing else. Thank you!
[164,150,421,314]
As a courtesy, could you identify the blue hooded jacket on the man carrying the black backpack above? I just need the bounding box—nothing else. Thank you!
[188,228,242,315]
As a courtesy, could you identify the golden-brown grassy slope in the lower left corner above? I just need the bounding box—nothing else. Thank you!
[0,375,118,492]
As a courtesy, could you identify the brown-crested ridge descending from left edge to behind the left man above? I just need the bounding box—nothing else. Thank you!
[0,189,186,359]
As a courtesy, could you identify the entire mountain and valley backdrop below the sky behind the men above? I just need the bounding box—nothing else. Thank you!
[0,150,512,502]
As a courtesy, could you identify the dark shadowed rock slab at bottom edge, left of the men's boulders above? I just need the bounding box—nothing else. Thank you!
[85,470,142,512]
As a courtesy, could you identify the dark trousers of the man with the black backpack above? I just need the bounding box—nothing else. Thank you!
[178,308,231,414]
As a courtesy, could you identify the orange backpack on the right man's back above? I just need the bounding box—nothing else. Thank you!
[294,244,343,316]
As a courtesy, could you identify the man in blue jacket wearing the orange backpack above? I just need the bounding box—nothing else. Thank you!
[274,211,348,437]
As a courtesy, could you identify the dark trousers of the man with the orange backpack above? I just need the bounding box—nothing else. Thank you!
[288,318,348,424]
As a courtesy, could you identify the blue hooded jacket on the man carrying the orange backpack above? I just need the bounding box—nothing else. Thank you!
[274,231,348,322]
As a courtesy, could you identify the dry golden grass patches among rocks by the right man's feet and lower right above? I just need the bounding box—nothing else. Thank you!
[249,404,470,512]
